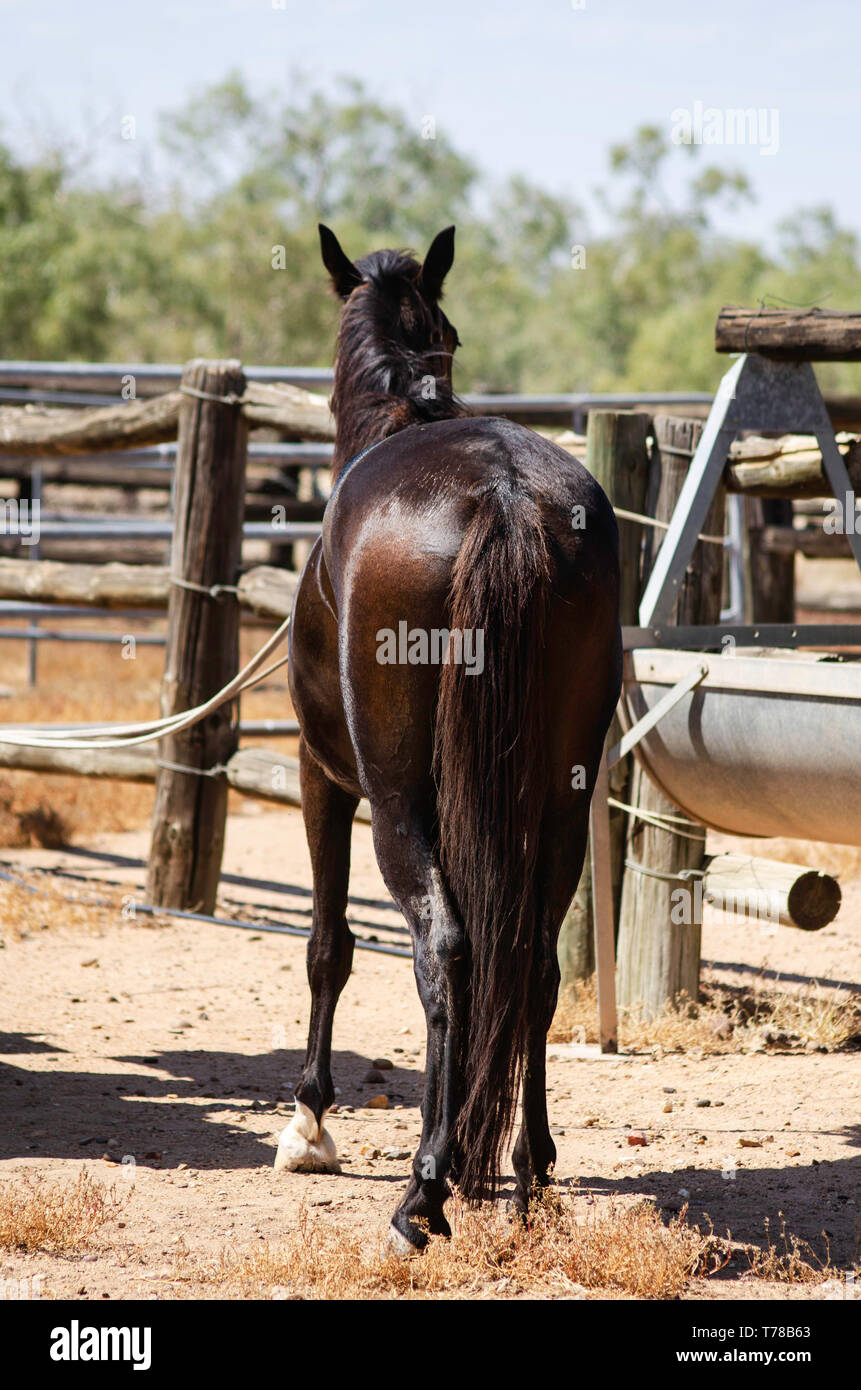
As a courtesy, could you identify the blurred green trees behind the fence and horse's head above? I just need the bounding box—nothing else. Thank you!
[0,80,861,391]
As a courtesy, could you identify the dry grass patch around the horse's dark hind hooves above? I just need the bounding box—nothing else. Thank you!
[179,1190,729,1298]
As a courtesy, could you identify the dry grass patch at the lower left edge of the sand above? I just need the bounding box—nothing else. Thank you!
[0,1169,131,1255]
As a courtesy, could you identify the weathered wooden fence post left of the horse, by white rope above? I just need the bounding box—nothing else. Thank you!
[146,361,248,913]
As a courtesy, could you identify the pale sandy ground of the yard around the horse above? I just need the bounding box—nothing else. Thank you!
[0,811,861,1298]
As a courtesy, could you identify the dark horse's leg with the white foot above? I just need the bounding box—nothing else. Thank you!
[275,742,357,1173]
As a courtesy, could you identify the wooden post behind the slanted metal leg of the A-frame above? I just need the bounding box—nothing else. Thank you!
[618,416,723,1019]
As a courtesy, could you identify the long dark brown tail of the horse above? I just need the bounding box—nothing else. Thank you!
[434,481,551,1201]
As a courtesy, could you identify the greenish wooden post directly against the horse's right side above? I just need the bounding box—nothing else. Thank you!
[558,410,651,988]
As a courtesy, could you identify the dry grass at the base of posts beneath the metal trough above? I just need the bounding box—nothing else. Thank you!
[549,979,861,1055]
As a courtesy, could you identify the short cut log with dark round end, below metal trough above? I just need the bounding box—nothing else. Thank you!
[702,855,842,931]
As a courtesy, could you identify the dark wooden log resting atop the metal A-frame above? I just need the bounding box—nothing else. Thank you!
[715,304,861,361]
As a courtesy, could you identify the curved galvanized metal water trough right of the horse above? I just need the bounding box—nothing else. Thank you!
[622,648,861,845]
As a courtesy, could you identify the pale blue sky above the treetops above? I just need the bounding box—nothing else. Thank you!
[0,0,861,243]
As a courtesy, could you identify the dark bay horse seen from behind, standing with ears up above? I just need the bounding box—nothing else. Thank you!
[275,227,622,1248]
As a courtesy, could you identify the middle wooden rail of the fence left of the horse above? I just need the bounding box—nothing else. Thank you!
[0,559,299,623]
